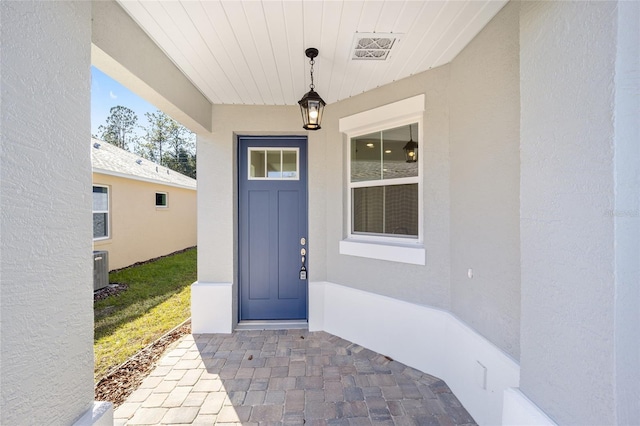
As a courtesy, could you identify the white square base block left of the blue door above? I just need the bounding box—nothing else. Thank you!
[191,281,233,334]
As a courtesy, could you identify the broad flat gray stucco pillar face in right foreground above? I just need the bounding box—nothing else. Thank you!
[520,2,620,424]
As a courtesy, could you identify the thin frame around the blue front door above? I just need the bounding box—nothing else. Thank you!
[239,134,310,323]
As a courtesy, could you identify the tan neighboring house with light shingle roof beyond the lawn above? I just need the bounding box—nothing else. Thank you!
[91,139,196,269]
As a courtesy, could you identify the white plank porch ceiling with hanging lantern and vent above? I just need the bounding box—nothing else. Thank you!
[119,0,507,105]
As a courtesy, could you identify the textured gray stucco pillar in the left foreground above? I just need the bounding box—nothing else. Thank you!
[0,1,93,425]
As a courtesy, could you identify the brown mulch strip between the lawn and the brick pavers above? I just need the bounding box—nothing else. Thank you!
[95,319,191,408]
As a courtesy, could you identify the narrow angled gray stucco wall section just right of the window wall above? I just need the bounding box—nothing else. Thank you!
[449,2,520,359]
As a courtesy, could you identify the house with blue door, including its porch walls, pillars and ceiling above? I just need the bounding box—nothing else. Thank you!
[0,1,640,425]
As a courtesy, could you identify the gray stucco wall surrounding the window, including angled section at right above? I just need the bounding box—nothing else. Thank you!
[323,0,520,359]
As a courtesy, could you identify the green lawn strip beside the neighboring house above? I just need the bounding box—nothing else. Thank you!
[94,248,196,381]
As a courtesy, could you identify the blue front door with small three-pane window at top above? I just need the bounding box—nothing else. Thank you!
[238,137,308,321]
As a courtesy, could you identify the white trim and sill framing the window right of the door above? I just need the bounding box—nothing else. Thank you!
[339,95,426,265]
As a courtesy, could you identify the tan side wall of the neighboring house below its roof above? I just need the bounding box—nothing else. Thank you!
[93,173,197,269]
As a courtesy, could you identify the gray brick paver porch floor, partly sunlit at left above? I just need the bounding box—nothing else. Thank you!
[115,330,475,426]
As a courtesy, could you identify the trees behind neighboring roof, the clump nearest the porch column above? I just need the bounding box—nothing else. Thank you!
[137,111,196,178]
